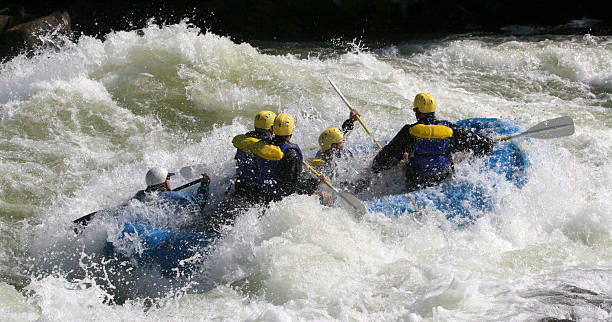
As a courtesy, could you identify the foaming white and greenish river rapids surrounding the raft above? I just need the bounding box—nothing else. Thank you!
[0,24,612,321]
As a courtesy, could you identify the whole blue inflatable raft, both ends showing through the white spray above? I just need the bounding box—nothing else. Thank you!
[104,118,529,276]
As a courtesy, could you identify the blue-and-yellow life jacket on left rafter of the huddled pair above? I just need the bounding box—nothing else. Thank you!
[232,131,260,192]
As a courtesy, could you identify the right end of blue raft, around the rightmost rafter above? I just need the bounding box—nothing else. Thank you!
[367,118,529,225]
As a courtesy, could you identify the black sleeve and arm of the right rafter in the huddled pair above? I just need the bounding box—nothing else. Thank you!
[277,149,319,195]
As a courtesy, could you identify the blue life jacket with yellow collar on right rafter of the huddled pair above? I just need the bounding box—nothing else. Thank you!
[251,139,304,197]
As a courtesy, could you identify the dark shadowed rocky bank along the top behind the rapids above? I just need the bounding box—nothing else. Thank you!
[0,0,612,60]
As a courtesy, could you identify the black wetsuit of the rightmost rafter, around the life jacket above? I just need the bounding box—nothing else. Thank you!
[372,114,493,191]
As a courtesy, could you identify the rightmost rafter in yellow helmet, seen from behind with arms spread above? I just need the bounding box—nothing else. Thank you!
[372,93,493,192]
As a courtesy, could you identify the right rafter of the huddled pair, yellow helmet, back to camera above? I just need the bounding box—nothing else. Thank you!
[251,113,327,203]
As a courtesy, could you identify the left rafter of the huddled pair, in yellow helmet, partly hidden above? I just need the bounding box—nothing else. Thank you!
[232,111,276,203]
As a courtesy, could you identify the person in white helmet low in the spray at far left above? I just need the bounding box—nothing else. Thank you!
[132,167,210,212]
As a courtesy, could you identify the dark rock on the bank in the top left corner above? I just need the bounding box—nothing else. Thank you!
[0,11,71,59]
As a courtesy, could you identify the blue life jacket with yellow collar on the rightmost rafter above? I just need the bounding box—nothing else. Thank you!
[409,121,453,177]
